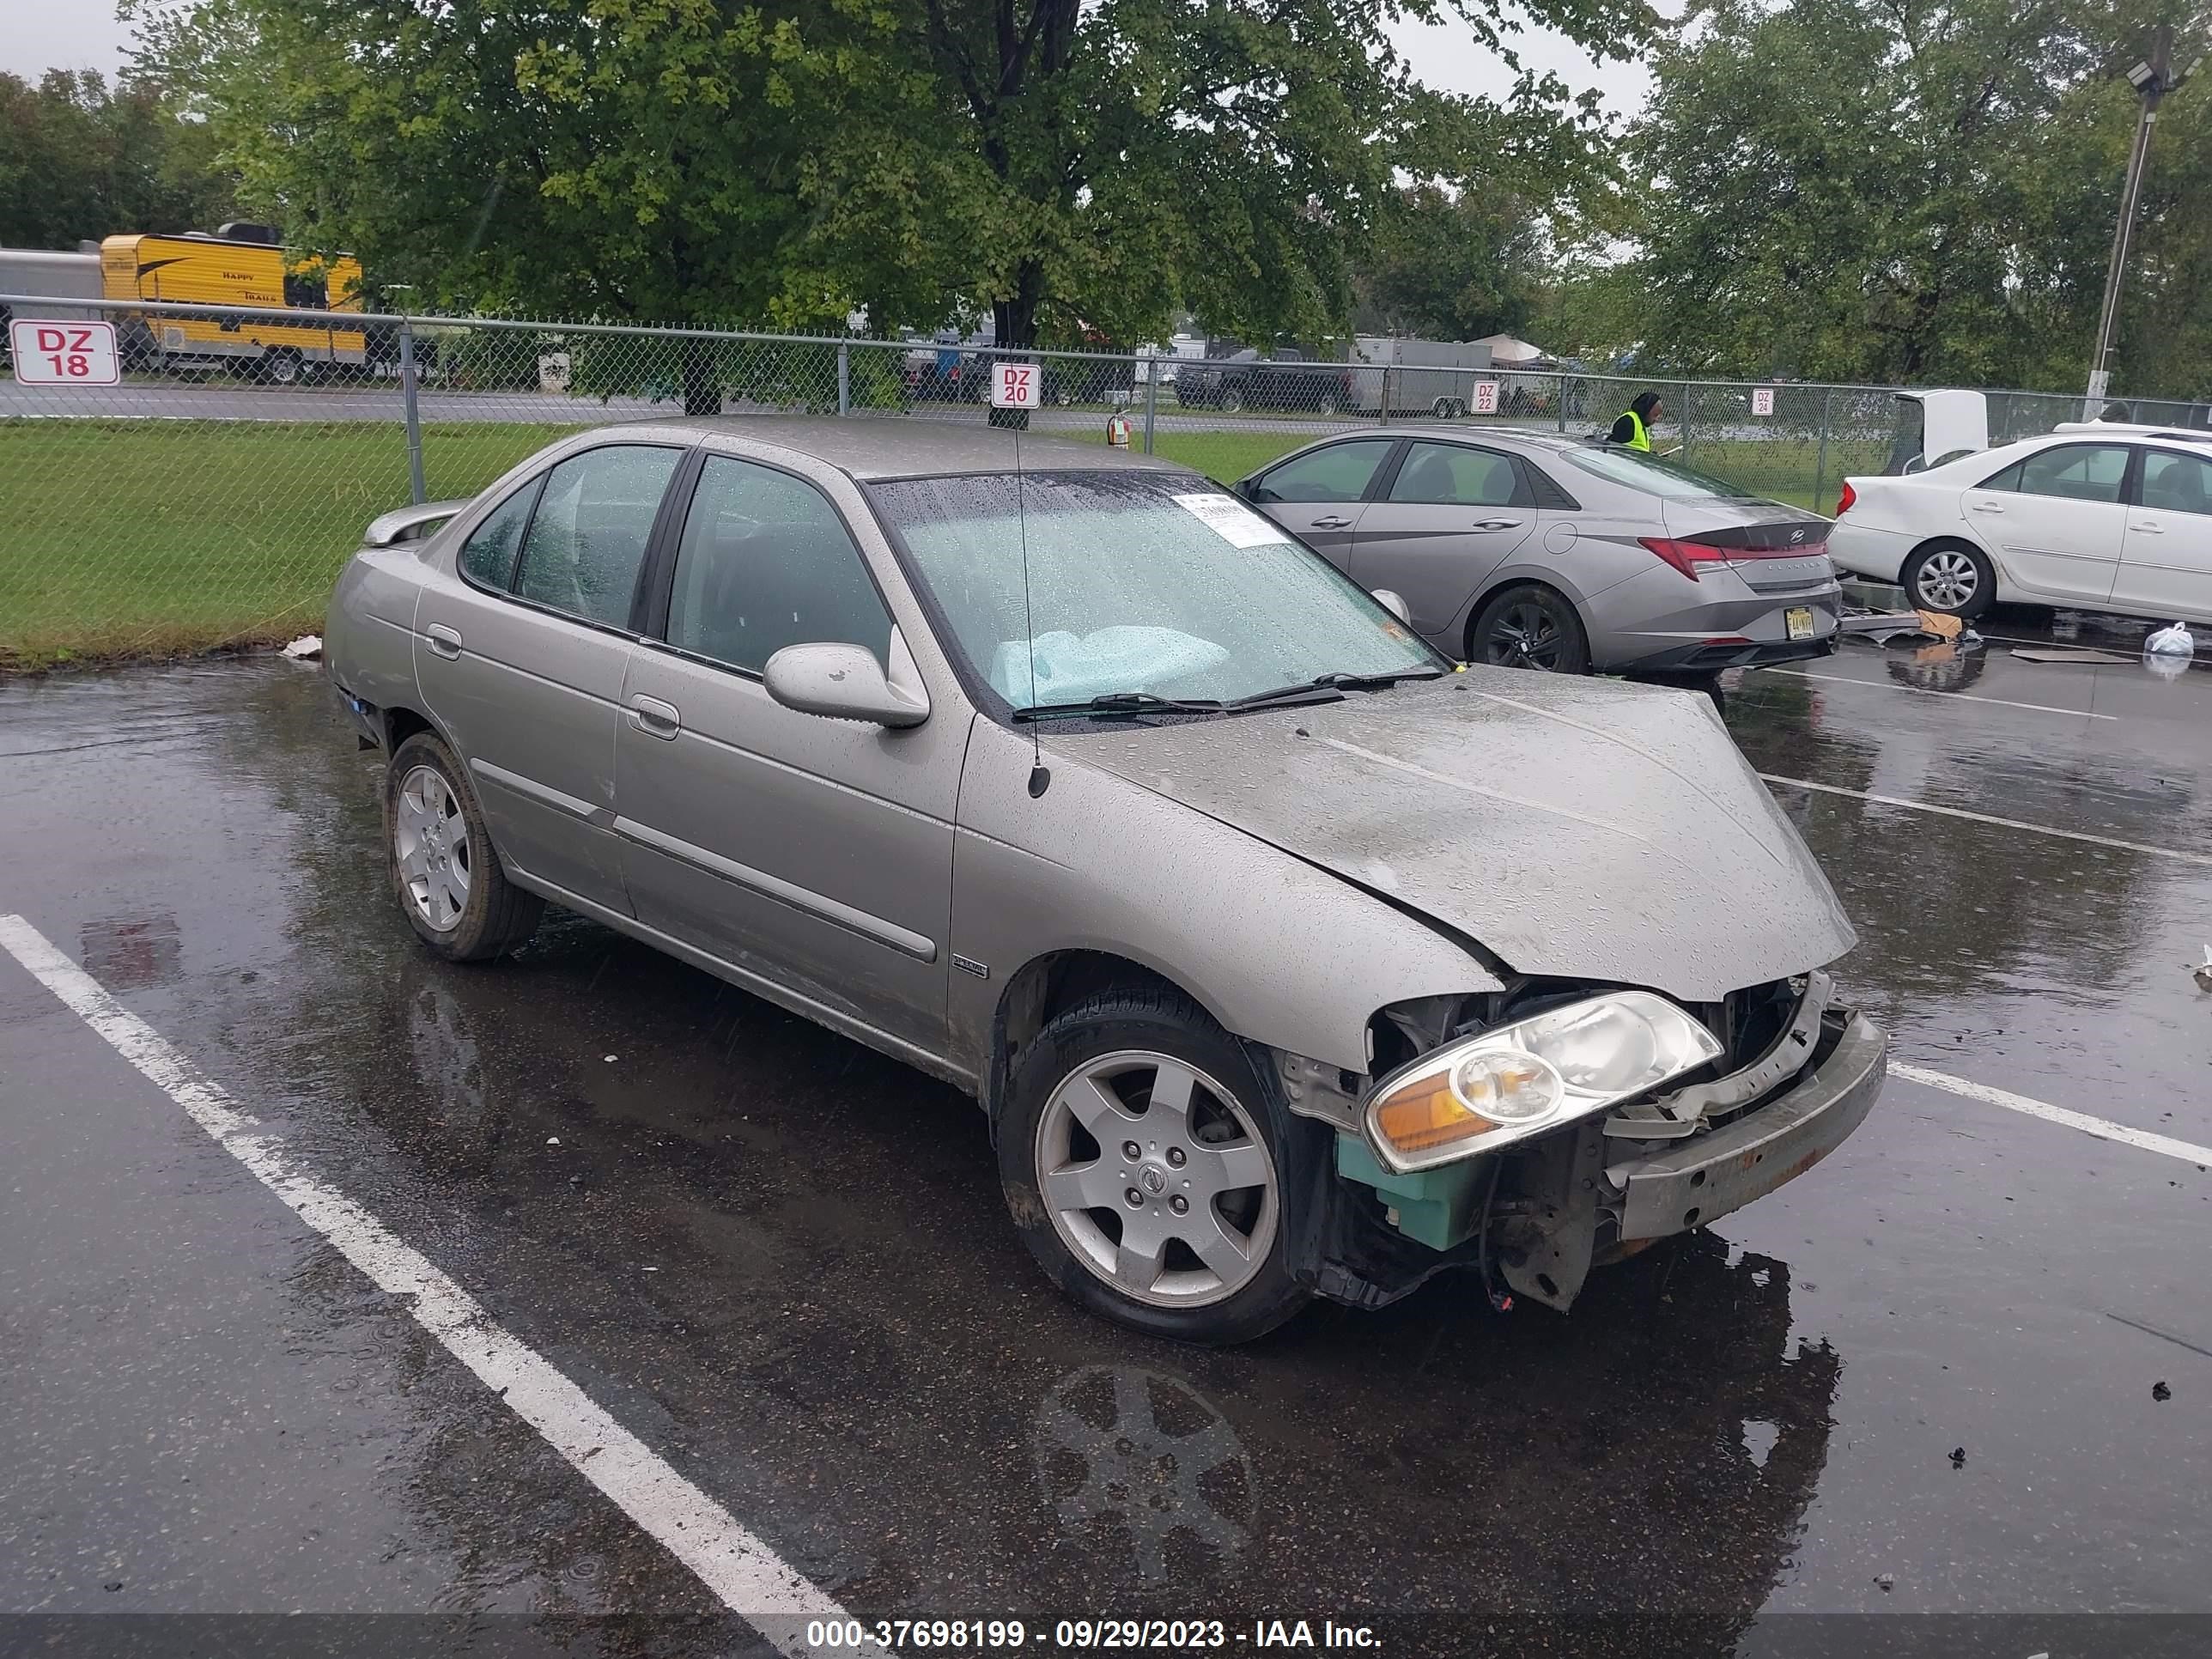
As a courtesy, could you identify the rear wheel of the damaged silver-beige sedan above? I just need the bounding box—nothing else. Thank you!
[385,732,546,963]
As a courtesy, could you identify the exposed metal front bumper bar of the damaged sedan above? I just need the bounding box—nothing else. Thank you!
[1606,1011,1889,1243]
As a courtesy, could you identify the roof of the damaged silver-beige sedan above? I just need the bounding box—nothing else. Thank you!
[570,416,1190,480]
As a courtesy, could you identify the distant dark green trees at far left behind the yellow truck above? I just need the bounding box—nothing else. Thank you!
[0,69,234,248]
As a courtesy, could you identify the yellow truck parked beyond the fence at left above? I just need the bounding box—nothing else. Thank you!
[100,223,389,385]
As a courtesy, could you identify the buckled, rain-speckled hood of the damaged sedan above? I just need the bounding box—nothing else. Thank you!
[1044,668,1856,1002]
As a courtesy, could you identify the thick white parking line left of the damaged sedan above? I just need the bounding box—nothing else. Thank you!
[0,915,849,1656]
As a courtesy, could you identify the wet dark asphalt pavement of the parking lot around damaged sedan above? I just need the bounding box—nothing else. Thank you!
[0,617,2212,1659]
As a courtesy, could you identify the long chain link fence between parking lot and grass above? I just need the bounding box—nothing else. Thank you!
[0,296,2205,671]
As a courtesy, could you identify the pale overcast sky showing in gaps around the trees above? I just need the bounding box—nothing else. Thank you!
[0,0,1650,115]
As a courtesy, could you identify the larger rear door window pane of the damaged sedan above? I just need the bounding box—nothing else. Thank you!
[515,445,684,629]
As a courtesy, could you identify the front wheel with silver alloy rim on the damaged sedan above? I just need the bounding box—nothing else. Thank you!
[998,991,1307,1345]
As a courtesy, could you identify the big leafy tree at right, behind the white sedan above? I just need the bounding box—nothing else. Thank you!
[1631,0,2194,385]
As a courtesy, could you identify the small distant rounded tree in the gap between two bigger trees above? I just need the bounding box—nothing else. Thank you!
[1354,184,1544,341]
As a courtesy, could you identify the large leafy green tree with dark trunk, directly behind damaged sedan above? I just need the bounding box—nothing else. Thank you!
[149,0,1655,403]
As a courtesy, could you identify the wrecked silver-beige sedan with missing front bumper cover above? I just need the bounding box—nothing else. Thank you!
[325,418,1885,1343]
